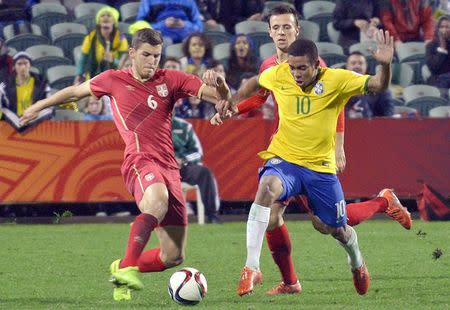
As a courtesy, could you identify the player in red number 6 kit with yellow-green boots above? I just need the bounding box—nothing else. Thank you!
[21,29,231,300]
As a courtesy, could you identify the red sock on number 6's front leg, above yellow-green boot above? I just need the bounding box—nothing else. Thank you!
[119,213,158,268]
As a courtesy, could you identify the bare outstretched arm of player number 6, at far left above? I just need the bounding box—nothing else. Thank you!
[20,81,91,126]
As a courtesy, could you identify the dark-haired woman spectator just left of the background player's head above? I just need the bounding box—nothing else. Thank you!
[227,34,259,89]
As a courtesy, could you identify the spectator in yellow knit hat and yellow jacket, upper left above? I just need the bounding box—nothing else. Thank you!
[75,6,128,84]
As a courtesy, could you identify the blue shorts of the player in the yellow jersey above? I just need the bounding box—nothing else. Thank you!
[259,157,347,227]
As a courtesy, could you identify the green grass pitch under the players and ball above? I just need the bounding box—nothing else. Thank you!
[0,220,450,309]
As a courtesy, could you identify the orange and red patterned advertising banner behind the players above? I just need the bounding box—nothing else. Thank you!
[0,119,450,202]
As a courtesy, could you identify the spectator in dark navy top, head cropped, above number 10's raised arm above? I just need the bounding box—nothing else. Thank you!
[333,0,380,53]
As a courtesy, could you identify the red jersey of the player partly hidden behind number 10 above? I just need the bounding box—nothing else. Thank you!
[237,54,345,132]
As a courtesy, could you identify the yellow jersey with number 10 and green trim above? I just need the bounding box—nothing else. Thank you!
[258,63,370,173]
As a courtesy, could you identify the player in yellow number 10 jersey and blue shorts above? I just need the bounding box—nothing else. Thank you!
[218,30,394,295]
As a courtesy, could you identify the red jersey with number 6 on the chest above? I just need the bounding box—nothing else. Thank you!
[90,69,203,169]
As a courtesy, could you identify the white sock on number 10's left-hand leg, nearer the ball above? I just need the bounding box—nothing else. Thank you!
[245,203,270,270]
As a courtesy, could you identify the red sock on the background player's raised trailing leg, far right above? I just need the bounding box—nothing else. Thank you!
[347,197,388,226]
